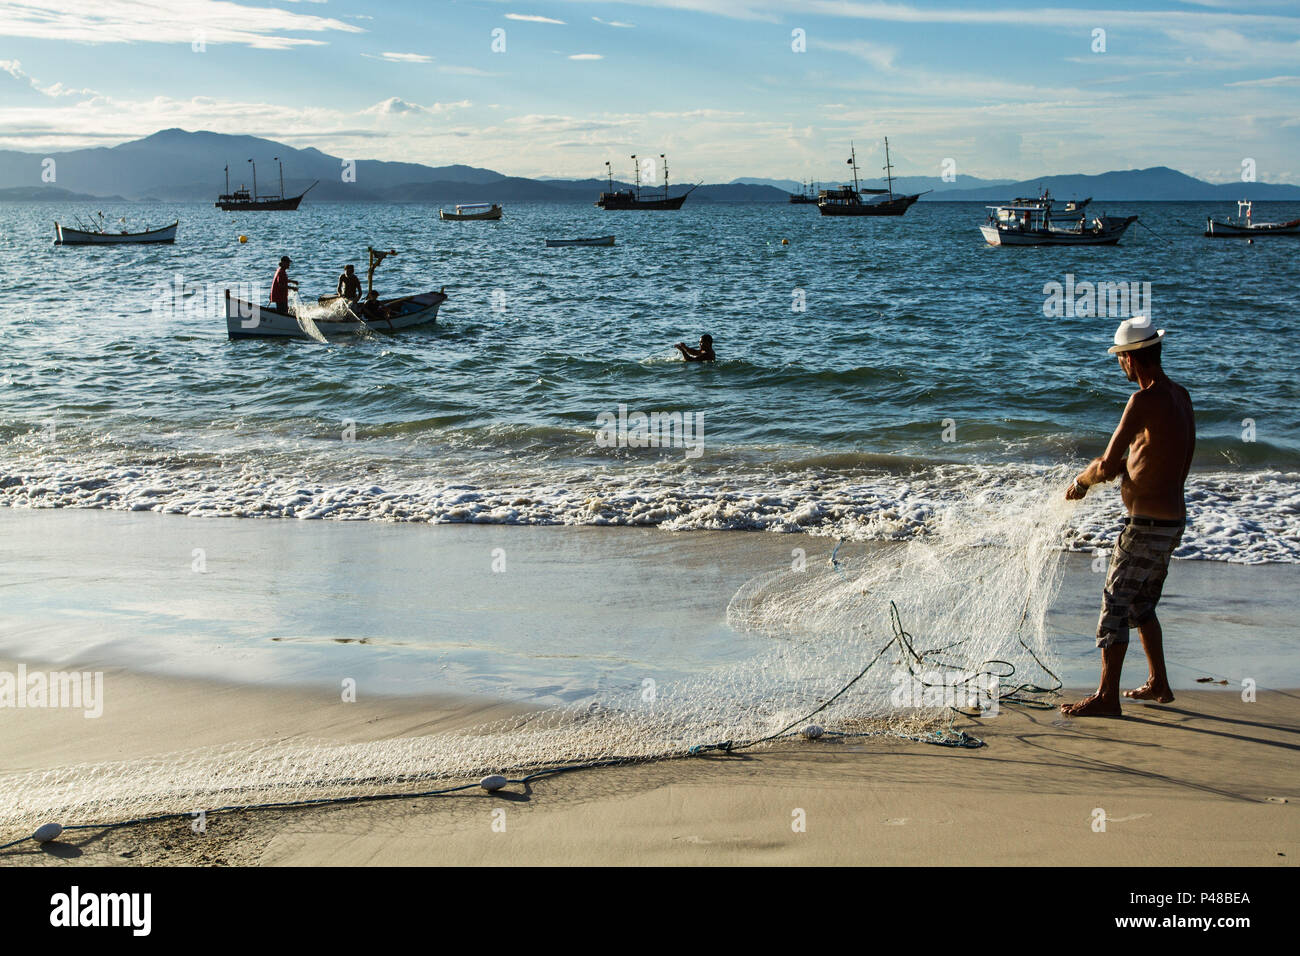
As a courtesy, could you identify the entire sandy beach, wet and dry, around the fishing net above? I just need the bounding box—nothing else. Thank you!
[0,510,1300,866]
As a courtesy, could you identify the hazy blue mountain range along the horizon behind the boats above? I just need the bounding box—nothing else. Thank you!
[0,129,1300,203]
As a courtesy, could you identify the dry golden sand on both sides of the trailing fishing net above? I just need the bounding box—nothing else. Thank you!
[0,672,1300,866]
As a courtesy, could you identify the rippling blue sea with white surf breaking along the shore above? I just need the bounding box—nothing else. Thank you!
[0,195,1300,563]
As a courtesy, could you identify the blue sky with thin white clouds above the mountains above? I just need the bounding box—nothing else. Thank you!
[0,0,1300,183]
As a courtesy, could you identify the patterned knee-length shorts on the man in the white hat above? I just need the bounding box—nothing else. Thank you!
[1097,518,1187,648]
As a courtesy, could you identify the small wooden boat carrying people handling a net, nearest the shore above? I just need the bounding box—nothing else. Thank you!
[226,248,447,339]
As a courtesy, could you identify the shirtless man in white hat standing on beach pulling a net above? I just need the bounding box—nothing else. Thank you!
[1061,316,1196,717]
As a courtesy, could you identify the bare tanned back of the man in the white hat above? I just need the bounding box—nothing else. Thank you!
[1119,375,1196,519]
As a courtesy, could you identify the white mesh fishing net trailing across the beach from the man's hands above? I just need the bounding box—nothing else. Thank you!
[0,481,1070,835]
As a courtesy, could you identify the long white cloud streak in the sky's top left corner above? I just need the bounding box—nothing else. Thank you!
[0,0,365,49]
